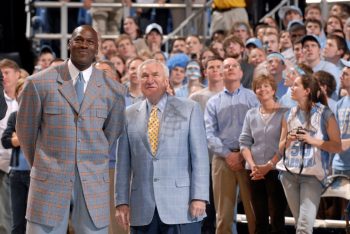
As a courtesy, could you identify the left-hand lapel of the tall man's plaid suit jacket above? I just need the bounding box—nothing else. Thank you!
[57,61,79,113]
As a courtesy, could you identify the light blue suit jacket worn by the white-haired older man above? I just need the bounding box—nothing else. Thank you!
[116,96,209,226]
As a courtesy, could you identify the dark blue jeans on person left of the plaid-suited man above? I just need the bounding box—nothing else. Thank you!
[9,170,30,234]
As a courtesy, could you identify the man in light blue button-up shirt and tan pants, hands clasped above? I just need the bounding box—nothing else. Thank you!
[204,58,259,234]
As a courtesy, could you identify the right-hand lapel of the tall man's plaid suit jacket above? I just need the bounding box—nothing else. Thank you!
[80,68,102,114]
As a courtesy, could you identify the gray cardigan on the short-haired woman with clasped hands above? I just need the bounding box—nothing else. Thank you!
[239,107,288,169]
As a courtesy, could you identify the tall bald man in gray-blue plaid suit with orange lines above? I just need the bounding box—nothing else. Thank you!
[17,25,125,234]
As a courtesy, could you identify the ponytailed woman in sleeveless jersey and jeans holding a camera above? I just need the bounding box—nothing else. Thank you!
[276,75,341,233]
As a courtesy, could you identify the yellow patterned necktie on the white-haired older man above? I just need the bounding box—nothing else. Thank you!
[148,106,159,156]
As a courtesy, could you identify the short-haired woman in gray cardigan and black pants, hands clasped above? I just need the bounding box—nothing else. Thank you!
[239,75,287,233]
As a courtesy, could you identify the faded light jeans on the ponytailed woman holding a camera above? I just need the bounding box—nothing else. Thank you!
[280,172,323,234]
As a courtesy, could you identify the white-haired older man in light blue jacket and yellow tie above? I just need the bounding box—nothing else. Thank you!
[116,60,209,234]
